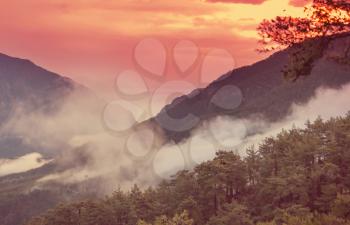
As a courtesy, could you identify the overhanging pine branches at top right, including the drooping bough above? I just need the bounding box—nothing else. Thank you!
[258,0,350,80]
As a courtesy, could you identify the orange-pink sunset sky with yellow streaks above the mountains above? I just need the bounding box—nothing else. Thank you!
[0,0,308,98]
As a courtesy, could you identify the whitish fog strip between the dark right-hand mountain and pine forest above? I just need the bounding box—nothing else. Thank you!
[156,84,350,178]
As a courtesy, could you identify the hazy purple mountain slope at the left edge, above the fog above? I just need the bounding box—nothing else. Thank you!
[0,54,76,117]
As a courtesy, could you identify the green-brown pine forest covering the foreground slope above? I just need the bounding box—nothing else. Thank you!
[28,114,350,225]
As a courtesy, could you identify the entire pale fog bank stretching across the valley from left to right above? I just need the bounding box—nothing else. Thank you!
[0,82,350,193]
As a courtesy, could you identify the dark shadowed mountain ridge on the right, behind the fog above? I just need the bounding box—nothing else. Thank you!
[152,34,350,142]
